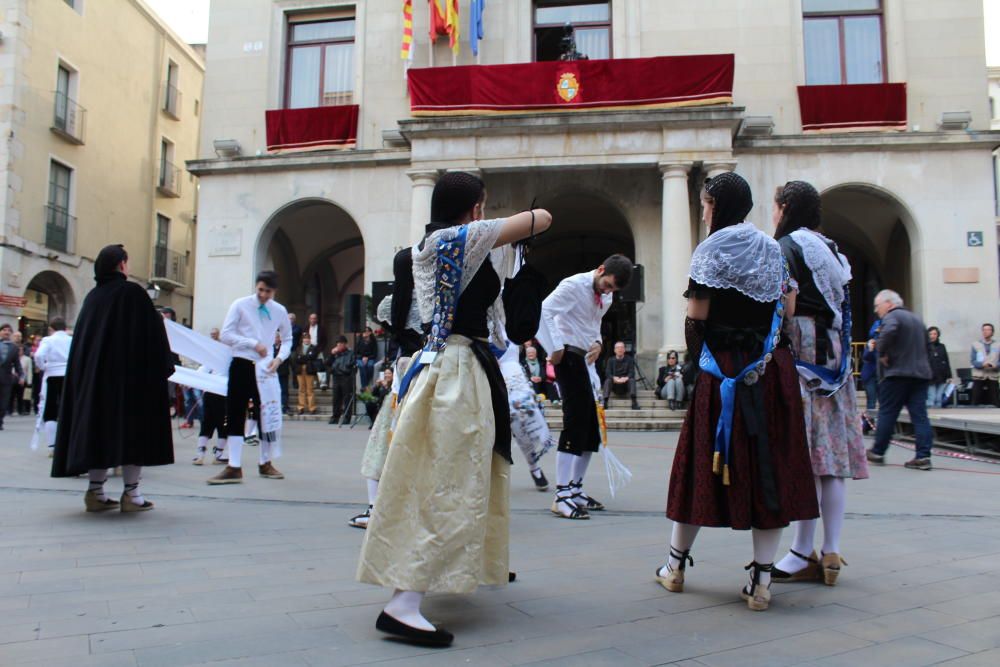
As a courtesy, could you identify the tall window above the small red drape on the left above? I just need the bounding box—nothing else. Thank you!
[285,16,355,109]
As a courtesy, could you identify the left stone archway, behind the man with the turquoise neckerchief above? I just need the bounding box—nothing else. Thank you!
[256,199,365,341]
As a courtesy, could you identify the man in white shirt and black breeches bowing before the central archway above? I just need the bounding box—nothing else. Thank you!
[537,255,632,519]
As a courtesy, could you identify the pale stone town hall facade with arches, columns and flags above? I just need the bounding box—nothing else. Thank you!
[188,0,1000,369]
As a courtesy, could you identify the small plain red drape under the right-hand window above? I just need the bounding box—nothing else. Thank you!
[799,83,906,132]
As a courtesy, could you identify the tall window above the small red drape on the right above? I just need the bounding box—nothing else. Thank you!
[802,0,886,86]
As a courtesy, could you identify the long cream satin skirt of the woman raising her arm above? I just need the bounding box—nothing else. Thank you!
[357,335,510,593]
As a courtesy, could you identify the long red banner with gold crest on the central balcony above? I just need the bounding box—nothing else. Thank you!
[407,54,734,116]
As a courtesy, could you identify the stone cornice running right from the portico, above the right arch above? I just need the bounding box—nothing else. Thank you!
[733,130,1000,155]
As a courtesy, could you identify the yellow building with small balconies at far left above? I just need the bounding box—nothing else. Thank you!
[0,0,204,333]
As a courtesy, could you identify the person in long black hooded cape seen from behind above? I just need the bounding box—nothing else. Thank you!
[52,245,174,512]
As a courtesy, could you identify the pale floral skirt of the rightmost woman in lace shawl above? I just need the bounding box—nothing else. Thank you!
[789,317,868,479]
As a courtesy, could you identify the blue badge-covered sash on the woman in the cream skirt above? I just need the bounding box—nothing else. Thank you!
[399,225,469,400]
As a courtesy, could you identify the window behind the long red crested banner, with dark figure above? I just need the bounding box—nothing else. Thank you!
[534,0,611,62]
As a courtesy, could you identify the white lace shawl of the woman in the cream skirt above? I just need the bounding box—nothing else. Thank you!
[413,218,513,349]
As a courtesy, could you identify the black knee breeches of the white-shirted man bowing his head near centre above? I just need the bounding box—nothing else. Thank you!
[555,350,601,454]
